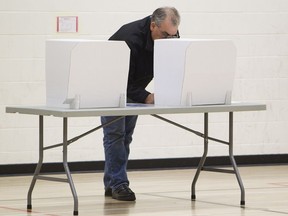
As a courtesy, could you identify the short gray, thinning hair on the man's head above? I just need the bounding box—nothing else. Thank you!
[151,7,180,26]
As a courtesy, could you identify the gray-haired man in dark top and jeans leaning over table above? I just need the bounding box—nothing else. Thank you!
[101,7,180,201]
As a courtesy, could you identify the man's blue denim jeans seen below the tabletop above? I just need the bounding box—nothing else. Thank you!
[101,116,138,190]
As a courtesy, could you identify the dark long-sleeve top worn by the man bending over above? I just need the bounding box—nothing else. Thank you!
[109,16,154,103]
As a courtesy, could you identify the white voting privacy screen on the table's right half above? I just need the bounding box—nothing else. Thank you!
[154,39,236,106]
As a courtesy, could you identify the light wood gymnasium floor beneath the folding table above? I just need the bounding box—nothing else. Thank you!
[0,165,288,216]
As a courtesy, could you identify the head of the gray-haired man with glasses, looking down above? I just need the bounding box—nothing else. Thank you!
[150,7,180,40]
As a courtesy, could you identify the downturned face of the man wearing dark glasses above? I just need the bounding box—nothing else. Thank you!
[150,17,178,40]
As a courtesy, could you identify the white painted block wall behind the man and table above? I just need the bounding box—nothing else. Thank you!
[0,0,288,164]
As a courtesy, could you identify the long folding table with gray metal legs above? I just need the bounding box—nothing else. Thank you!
[6,102,266,215]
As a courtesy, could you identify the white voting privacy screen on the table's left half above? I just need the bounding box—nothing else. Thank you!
[45,39,130,109]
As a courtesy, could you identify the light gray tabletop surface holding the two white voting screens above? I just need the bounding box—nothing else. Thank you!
[6,102,266,117]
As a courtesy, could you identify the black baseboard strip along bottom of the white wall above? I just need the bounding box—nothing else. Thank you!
[0,154,288,175]
